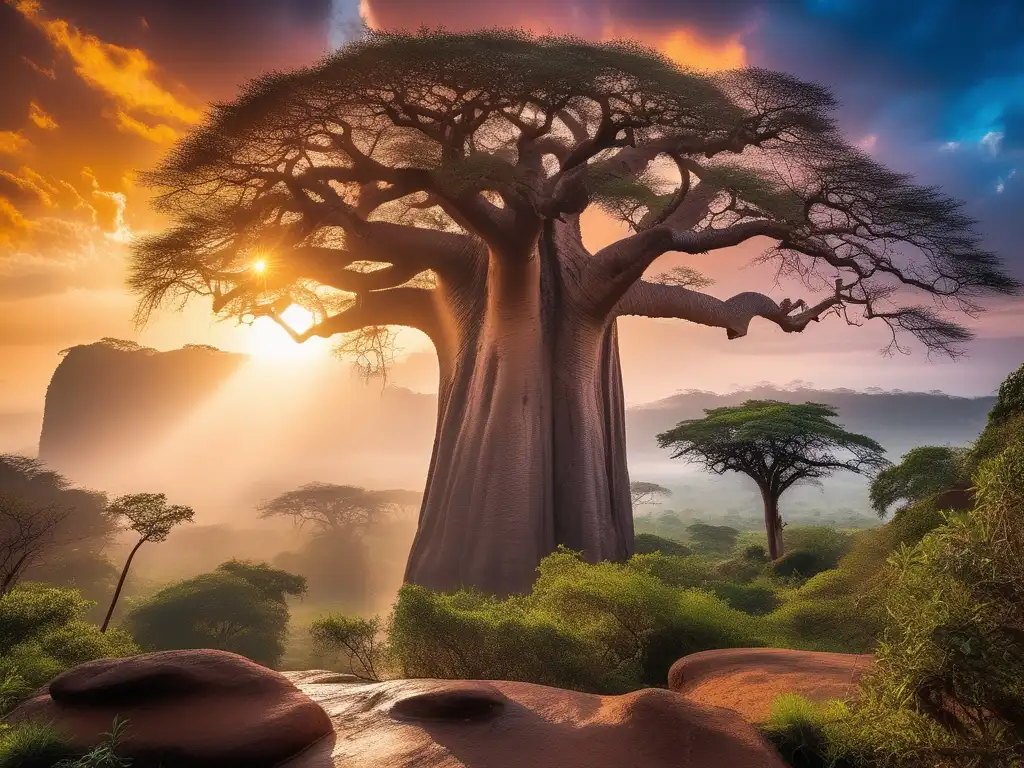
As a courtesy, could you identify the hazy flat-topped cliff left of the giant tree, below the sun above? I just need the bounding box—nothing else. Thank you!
[39,339,246,476]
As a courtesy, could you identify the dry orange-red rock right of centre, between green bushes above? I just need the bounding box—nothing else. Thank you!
[669,648,873,723]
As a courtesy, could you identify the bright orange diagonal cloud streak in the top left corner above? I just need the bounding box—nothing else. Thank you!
[6,0,202,134]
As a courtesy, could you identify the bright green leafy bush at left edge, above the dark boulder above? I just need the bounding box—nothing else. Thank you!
[0,584,139,706]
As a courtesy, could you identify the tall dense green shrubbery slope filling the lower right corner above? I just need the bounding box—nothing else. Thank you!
[766,423,1024,768]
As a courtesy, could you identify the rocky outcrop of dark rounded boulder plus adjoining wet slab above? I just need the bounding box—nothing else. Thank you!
[12,650,783,768]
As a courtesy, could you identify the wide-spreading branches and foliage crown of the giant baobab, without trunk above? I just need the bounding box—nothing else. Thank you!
[130,31,1020,352]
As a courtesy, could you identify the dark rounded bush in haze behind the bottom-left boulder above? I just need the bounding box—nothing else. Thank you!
[124,560,305,667]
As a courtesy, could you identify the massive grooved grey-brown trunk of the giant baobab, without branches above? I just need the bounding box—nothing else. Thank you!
[406,224,633,595]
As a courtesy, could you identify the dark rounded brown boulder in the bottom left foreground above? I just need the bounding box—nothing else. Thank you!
[11,650,333,768]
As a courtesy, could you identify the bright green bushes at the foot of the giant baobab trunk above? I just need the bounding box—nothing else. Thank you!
[312,551,773,692]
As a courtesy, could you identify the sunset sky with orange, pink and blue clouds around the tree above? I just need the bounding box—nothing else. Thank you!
[0,0,1024,423]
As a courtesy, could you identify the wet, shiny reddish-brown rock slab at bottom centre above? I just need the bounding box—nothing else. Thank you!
[282,680,783,768]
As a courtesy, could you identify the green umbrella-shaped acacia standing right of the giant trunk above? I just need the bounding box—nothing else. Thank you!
[657,400,889,560]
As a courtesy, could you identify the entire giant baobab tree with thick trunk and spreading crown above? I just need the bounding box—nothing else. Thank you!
[130,31,1017,594]
